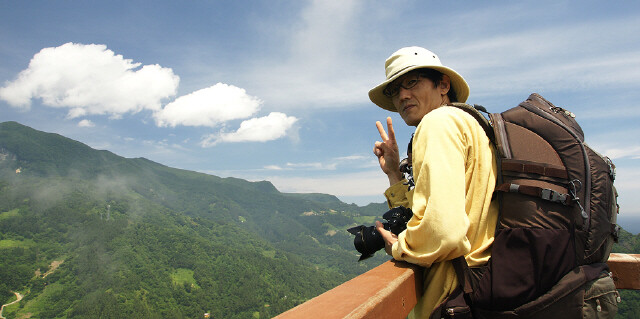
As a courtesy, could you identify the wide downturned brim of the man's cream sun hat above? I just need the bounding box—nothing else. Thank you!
[369,65,469,112]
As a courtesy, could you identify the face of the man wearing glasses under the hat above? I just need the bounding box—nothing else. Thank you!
[389,70,449,126]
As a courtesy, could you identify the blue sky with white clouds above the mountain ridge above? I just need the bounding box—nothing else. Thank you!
[0,0,640,225]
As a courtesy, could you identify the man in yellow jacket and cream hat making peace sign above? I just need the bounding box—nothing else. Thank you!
[369,47,498,318]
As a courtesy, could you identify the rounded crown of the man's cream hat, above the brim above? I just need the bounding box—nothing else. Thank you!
[384,47,442,79]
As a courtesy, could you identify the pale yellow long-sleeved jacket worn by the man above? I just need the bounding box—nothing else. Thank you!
[385,107,498,318]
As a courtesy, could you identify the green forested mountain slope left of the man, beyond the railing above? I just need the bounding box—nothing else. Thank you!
[0,122,388,318]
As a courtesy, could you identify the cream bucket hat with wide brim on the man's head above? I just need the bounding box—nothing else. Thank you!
[369,47,469,112]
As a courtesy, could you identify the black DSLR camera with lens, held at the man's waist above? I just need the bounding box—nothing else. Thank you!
[347,206,413,261]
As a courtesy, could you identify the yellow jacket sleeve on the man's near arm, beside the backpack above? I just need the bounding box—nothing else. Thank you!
[392,107,470,267]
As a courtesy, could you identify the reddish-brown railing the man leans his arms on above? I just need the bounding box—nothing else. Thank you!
[276,254,640,319]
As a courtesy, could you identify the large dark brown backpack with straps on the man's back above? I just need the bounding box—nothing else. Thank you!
[443,93,619,318]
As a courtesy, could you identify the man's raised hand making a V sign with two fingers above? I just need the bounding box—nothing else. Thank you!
[373,117,402,185]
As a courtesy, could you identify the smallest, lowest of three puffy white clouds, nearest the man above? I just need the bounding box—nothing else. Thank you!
[200,112,298,147]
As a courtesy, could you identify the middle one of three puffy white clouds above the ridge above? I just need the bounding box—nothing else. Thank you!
[154,83,262,127]
